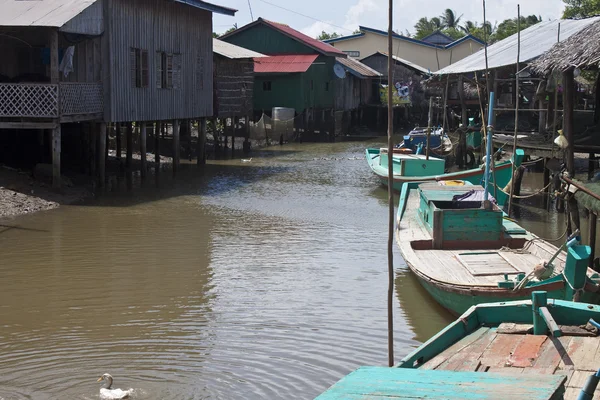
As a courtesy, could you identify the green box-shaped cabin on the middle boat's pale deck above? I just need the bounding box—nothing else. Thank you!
[418,181,504,249]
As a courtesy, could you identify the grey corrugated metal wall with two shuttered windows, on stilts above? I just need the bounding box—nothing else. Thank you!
[104,0,213,122]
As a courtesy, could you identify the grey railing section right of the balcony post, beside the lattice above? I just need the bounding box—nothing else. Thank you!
[60,82,104,116]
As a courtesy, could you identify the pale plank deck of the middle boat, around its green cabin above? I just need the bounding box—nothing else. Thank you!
[397,186,576,288]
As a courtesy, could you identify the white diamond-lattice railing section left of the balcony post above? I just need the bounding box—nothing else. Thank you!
[0,83,58,118]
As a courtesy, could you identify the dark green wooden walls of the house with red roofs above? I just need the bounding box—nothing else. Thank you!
[224,24,335,113]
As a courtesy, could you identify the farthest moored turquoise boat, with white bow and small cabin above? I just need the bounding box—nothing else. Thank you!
[365,148,522,200]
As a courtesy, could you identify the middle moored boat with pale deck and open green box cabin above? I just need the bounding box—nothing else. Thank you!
[396,178,600,314]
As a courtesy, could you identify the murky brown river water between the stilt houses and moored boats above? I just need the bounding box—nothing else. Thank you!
[0,142,576,400]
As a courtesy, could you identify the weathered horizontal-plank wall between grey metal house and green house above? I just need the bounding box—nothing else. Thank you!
[214,54,254,118]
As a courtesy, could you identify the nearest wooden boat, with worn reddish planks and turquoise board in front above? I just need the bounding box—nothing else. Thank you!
[317,291,600,400]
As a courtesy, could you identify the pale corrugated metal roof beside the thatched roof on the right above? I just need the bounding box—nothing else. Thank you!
[435,17,600,75]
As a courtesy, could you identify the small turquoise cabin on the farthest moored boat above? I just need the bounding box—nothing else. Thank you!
[379,147,446,176]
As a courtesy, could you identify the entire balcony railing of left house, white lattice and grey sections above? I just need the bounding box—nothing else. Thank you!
[0,82,104,118]
